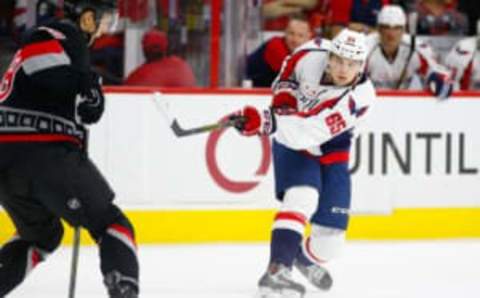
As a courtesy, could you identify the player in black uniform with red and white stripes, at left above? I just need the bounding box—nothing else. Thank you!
[0,2,139,298]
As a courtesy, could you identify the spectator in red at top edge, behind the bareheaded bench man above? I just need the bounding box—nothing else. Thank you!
[261,0,324,31]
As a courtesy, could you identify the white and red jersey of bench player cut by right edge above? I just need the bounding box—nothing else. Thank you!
[445,37,480,90]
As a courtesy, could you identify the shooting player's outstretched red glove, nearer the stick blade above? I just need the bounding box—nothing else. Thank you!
[230,106,276,136]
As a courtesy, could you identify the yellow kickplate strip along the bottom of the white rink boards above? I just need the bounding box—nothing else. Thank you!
[0,208,480,244]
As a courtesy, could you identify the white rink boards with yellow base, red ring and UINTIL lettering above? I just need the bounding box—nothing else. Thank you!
[0,89,480,243]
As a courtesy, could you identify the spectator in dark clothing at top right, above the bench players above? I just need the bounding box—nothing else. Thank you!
[416,0,468,35]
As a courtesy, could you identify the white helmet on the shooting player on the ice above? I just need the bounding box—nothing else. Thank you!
[331,29,367,62]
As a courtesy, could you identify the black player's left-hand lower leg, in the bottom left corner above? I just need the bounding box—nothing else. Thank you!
[0,236,48,297]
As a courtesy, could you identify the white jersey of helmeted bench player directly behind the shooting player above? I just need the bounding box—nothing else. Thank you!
[365,33,448,89]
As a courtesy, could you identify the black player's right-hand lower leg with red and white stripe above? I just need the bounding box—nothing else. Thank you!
[98,214,139,298]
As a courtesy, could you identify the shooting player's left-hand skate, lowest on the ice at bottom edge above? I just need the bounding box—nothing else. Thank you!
[257,263,306,298]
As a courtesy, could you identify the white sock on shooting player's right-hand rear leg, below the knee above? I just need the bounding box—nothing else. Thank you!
[303,224,345,263]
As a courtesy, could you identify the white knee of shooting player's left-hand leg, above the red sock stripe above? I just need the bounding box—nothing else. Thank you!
[280,186,318,219]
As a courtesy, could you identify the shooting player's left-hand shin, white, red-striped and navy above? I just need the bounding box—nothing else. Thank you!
[270,186,318,268]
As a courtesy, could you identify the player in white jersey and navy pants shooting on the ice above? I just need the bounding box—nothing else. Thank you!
[232,29,375,298]
